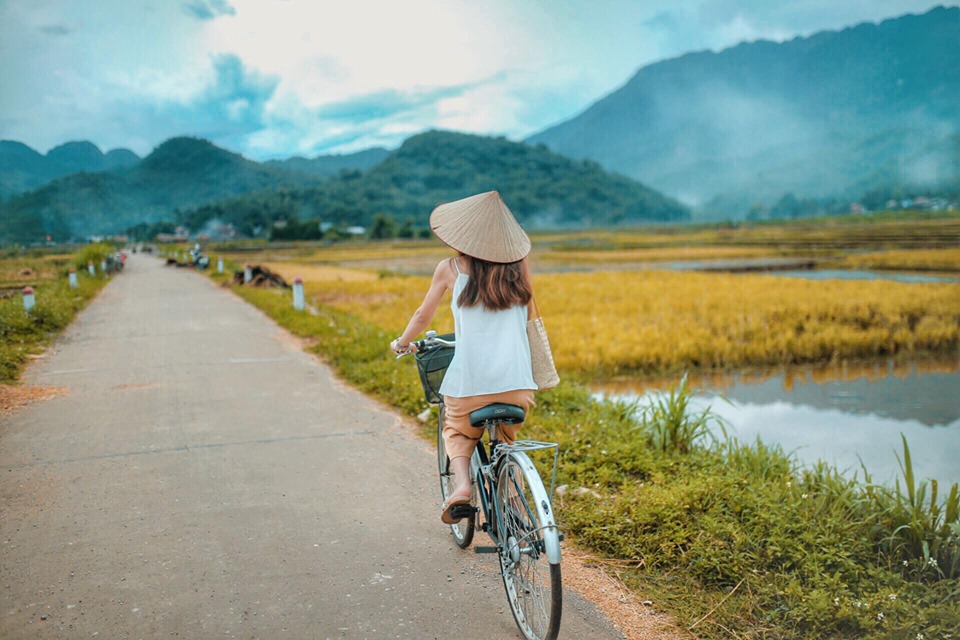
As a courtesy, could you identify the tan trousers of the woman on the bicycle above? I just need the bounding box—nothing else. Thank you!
[443,389,537,460]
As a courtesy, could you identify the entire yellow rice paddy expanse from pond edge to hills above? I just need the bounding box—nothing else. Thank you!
[216,218,960,379]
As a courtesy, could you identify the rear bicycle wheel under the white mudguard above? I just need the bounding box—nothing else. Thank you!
[495,452,563,640]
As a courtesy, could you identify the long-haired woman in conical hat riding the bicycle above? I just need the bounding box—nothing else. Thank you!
[390,191,537,524]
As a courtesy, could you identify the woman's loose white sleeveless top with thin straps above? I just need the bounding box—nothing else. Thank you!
[440,260,537,398]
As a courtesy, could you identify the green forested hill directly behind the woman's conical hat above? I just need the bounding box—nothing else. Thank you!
[180,131,689,234]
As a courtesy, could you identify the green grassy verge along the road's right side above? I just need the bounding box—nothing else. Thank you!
[213,276,960,640]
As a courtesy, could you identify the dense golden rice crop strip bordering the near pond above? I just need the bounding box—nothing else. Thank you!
[307,271,960,376]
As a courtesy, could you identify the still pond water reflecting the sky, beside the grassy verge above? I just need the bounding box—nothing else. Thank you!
[597,358,960,483]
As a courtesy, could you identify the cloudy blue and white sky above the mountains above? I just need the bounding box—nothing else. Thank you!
[0,0,957,160]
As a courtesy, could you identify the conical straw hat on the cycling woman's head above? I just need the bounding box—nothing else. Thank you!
[430,191,530,262]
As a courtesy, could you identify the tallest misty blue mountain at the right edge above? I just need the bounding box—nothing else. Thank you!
[528,7,960,213]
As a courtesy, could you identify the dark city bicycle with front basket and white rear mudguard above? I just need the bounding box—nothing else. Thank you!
[398,331,563,640]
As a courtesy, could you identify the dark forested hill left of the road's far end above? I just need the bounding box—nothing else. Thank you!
[0,138,307,242]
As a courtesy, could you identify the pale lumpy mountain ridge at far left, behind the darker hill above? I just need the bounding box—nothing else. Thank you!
[0,140,140,201]
